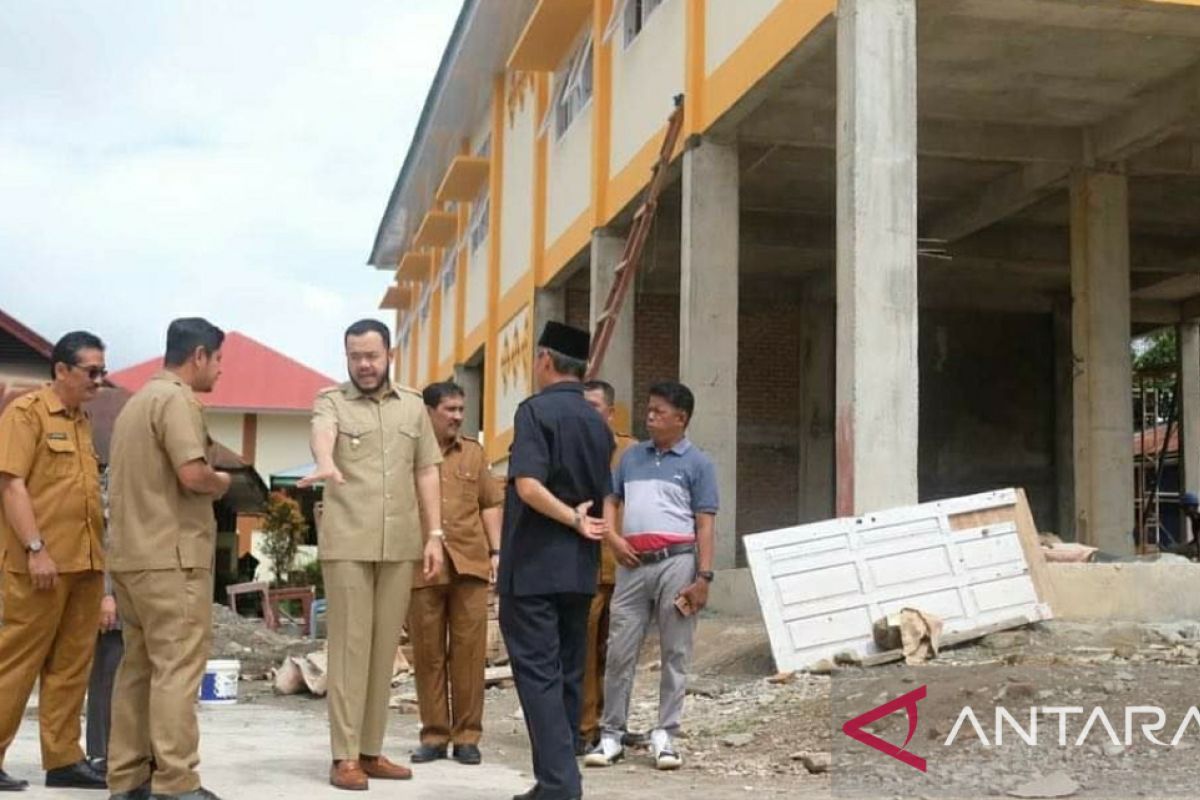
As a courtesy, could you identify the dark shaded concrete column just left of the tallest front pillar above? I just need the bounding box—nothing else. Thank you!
[797,276,836,523]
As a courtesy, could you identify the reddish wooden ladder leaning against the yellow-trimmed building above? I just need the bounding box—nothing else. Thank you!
[586,95,684,380]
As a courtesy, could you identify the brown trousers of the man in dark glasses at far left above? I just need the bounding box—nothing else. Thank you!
[0,571,104,770]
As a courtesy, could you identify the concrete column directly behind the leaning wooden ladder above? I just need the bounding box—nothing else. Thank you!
[588,228,637,432]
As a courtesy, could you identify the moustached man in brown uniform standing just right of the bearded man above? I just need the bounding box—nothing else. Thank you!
[408,381,504,765]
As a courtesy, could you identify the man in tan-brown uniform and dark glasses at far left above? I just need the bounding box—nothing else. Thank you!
[0,331,106,792]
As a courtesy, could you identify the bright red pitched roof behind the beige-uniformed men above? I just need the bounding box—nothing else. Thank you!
[108,331,337,411]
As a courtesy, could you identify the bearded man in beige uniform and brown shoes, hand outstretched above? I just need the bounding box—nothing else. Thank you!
[299,319,443,789]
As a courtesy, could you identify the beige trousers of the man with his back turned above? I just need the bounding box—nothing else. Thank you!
[108,570,212,794]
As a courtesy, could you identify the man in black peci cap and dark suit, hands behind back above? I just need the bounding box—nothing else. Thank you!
[497,323,613,800]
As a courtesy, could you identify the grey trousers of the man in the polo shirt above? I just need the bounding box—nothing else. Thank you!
[600,553,696,735]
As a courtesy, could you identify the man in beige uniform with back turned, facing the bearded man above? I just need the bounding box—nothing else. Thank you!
[108,318,229,800]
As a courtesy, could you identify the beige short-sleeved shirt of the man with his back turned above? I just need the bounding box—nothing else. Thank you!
[108,369,217,572]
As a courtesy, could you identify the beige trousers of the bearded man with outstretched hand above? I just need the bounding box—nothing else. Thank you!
[320,561,414,760]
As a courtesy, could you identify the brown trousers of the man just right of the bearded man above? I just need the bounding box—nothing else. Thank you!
[408,575,487,747]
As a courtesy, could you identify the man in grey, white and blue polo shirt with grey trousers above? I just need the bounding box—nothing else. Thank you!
[584,381,718,770]
